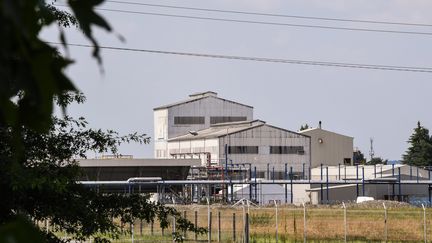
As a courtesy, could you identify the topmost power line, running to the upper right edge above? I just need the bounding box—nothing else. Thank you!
[105,0,432,27]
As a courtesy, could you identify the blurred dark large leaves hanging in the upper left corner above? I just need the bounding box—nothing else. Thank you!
[0,0,111,131]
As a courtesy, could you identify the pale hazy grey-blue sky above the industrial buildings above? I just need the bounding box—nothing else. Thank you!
[43,0,432,159]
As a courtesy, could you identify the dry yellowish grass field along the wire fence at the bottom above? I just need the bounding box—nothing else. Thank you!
[110,205,432,242]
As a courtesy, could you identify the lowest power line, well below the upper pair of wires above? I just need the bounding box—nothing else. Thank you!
[47,42,432,73]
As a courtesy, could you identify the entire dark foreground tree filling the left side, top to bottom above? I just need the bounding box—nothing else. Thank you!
[0,0,203,242]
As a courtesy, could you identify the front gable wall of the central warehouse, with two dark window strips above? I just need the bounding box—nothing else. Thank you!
[219,125,310,176]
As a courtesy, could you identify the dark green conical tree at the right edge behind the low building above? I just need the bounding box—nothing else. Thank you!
[402,121,432,166]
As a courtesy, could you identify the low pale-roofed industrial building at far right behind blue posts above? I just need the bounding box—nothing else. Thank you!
[305,164,431,204]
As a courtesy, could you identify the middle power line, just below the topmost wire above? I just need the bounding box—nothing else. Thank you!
[56,4,432,36]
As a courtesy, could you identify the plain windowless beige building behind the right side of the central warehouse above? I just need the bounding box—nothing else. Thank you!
[299,121,354,168]
